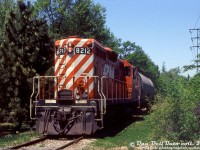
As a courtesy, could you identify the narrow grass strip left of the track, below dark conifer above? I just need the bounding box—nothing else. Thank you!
[0,132,39,148]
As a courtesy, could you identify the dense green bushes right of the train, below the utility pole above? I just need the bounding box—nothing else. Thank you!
[152,68,200,141]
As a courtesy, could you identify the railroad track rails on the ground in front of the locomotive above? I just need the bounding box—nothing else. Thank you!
[7,136,83,150]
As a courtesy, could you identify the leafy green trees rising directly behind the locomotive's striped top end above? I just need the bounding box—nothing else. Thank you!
[34,0,119,49]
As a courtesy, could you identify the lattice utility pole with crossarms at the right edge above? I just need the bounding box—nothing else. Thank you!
[189,28,200,73]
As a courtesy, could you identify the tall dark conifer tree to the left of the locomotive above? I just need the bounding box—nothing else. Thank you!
[0,1,53,126]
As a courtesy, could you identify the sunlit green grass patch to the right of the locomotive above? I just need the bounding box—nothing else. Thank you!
[92,115,153,149]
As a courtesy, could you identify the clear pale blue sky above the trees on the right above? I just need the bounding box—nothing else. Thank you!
[94,0,200,75]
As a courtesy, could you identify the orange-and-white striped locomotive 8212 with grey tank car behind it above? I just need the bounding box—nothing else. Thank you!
[30,37,154,135]
